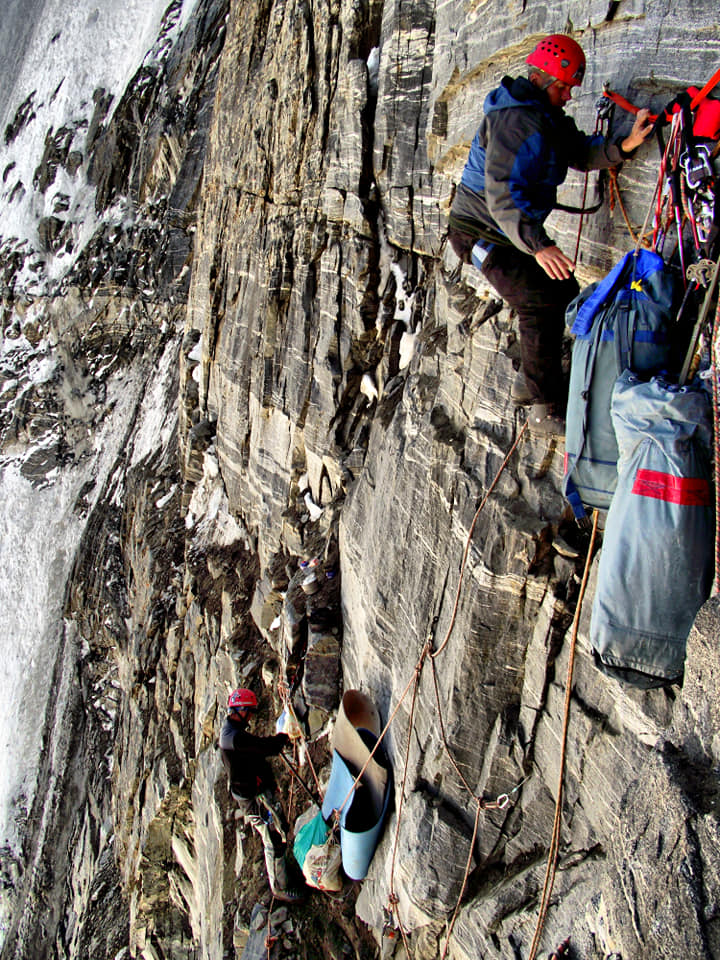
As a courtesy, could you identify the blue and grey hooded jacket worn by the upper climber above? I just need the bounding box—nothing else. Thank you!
[450,77,629,254]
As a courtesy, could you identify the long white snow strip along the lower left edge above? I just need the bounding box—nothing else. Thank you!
[0,348,157,872]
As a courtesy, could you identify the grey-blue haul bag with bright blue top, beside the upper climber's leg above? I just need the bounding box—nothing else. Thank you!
[563,250,675,519]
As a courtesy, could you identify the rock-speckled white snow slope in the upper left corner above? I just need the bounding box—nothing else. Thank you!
[0,0,196,293]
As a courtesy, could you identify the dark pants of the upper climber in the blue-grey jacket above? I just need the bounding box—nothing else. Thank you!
[448,230,580,413]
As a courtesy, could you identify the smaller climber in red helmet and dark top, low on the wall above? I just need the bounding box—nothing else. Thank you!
[219,687,302,902]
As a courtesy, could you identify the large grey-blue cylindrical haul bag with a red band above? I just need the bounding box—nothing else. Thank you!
[590,371,714,687]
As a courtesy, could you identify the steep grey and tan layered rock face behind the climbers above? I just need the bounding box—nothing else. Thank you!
[0,0,720,960]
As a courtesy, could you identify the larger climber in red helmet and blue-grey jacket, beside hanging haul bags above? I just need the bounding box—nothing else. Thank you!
[448,34,653,436]
